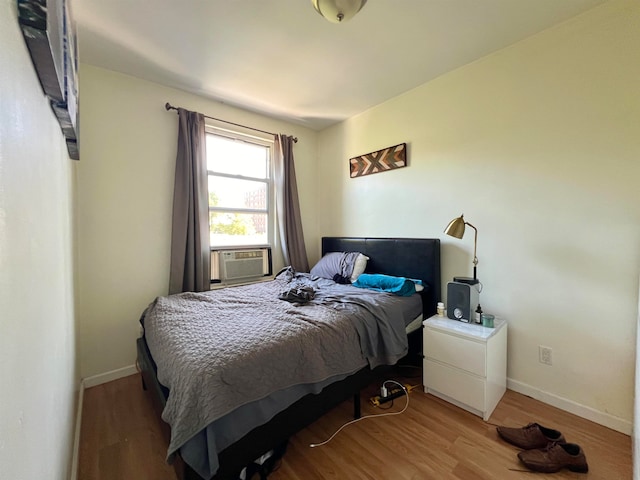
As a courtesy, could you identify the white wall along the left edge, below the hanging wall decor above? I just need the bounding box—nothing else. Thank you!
[0,0,78,480]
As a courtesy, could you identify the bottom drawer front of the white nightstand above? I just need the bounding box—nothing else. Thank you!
[424,360,485,411]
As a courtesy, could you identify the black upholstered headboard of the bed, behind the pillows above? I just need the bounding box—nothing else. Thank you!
[322,237,441,318]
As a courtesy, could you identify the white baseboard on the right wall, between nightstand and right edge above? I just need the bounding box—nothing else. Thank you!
[507,378,633,435]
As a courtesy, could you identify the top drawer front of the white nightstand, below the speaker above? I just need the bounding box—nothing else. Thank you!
[424,328,486,377]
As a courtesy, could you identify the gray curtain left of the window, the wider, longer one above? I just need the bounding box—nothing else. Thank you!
[169,108,211,294]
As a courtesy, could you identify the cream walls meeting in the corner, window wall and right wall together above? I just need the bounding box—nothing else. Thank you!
[78,0,640,432]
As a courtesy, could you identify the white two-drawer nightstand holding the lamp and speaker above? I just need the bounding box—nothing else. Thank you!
[423,316,507,421]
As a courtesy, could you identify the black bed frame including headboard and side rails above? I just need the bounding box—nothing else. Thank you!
[137,237,441,480]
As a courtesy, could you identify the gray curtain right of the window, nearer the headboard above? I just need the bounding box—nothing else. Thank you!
[274,135,309,272]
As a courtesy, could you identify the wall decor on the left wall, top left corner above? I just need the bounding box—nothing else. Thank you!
[17,0,80,160]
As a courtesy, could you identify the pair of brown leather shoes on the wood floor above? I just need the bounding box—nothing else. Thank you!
[496,423,589,473]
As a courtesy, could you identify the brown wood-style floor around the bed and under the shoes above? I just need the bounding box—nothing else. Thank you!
[78,375,632,480]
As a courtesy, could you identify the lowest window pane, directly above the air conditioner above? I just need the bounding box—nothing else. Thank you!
[209,212,269,246]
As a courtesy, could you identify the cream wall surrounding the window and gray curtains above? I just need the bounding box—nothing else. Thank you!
[78,64,318,378]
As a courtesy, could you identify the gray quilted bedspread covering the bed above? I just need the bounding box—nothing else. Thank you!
[144,274,407,471]
